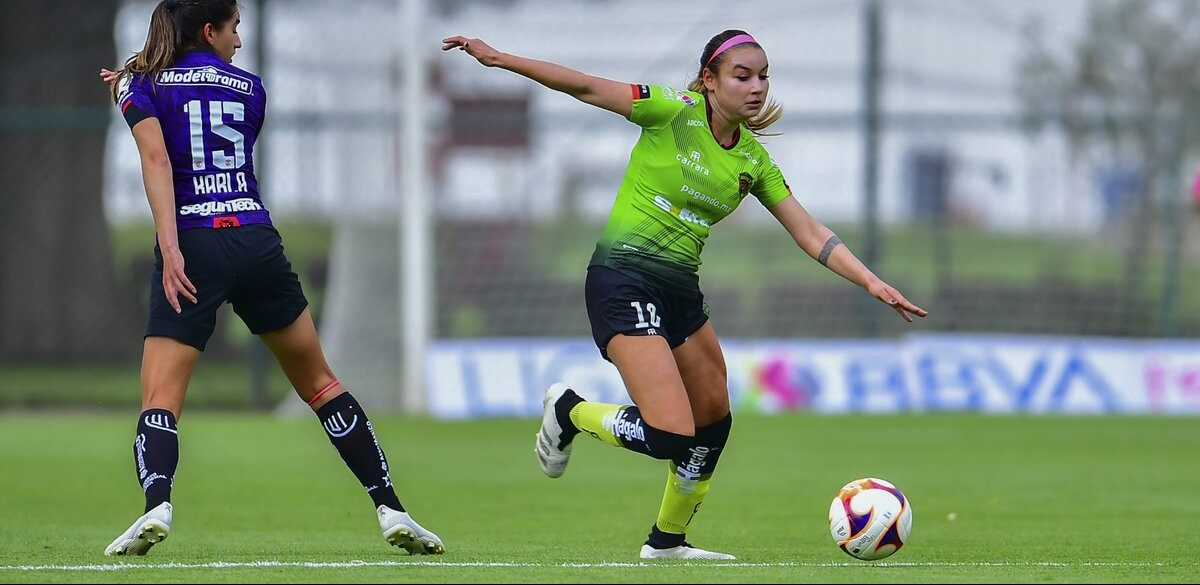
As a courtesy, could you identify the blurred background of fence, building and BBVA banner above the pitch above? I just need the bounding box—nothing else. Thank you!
[0,0,1200,417]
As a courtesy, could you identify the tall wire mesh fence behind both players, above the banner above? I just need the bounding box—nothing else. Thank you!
[0,0,1200,409]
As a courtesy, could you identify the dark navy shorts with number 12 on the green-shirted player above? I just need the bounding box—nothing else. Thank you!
[583,266,708,362]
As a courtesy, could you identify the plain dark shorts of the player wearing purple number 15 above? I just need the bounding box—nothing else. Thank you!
[145,224,308,351]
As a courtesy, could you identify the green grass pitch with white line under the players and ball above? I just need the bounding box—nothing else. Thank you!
[0,411,1200,583]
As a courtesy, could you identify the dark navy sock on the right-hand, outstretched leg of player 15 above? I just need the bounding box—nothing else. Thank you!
[317,392,404,512]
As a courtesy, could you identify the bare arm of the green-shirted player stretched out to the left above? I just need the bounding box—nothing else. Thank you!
[442,36,634,117]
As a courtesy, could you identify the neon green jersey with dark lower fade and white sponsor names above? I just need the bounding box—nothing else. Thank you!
[589,85,792,290]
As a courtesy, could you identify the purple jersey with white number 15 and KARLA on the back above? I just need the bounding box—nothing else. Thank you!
[118,50,271,230]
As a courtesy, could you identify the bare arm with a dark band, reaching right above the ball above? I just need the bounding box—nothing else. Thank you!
[769,197,929,322]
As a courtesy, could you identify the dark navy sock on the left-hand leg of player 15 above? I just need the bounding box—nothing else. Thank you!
[133,409,179,512]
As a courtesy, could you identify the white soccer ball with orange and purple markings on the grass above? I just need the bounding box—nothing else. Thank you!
[829,477,912,561]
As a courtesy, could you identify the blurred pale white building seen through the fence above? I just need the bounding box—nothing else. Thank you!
[107,0,1102,231]
